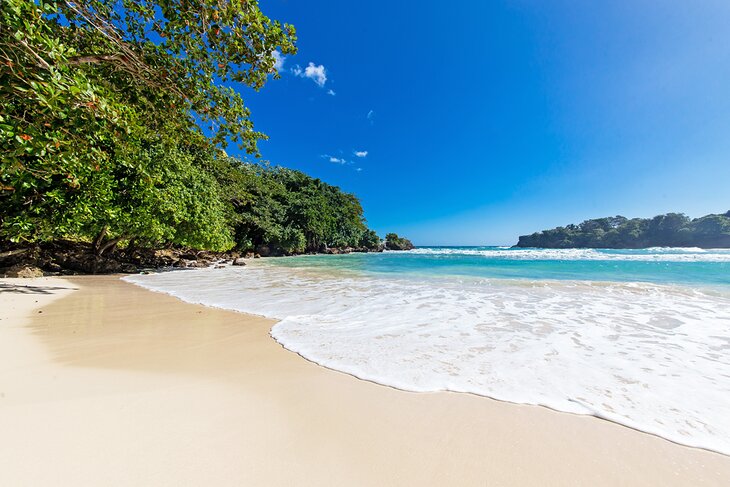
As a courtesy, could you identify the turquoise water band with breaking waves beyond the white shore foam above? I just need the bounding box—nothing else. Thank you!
[270,247,730,286]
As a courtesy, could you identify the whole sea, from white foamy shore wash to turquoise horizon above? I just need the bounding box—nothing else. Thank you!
[127,247,730,454]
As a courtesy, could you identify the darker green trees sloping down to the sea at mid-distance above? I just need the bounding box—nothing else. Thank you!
[202,158,380,254]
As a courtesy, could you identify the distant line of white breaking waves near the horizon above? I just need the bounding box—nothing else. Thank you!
[408,247,730,262]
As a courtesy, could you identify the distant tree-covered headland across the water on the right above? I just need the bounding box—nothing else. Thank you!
[517,211,730,249]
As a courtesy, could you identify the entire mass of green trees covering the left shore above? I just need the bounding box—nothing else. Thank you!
[0,0,404,269]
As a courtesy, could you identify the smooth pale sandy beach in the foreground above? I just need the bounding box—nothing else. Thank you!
[0,276,730,486]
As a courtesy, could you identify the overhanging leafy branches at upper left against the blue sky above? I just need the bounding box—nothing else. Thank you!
[54,0,296,154]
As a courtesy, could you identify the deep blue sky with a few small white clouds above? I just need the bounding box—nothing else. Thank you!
[236,0,730,245]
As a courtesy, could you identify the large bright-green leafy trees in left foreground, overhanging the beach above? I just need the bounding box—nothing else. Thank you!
[0,0,296,247]
